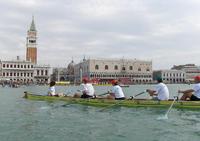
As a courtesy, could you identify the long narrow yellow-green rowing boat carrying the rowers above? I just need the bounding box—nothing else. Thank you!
[24,92,200,109]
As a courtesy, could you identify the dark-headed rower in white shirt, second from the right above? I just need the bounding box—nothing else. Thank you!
[146,77,169,100]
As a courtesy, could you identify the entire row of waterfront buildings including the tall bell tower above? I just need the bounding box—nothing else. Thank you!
[0,18,200,84]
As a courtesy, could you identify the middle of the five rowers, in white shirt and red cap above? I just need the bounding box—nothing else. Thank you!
[110,80,125,100]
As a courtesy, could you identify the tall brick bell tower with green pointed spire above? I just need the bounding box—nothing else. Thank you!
[26,17,37,64]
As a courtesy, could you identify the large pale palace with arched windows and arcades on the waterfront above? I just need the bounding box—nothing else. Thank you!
[74,59,152,84]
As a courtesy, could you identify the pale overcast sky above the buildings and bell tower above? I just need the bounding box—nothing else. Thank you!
[0,0,200,69]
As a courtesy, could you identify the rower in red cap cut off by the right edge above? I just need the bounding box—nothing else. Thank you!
[178,76,200,101]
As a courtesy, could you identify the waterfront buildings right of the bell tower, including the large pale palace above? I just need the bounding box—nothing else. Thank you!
[52,59,200,84]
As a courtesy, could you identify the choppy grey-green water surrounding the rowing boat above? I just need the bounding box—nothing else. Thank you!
[0,85,200,141]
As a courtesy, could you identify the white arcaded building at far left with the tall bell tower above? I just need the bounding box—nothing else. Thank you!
[0,18,50,84]
